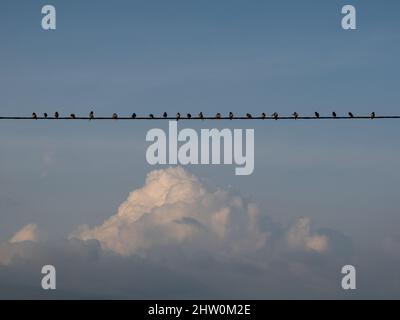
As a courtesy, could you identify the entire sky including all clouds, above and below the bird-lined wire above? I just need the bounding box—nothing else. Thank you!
[0,0,400,299]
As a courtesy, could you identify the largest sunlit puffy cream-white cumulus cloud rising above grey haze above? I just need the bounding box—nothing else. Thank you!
[74,167,267,255]
